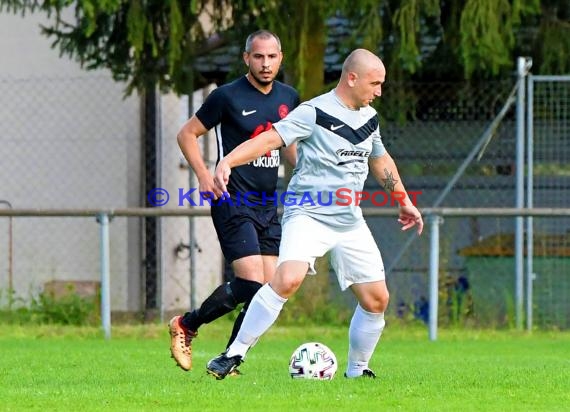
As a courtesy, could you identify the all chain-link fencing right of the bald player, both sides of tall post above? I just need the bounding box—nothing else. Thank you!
[371,76,570,328]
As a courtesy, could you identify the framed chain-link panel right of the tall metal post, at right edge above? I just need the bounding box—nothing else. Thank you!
[527,76,570,328]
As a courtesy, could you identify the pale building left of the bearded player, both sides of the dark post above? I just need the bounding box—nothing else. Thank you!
[0,14,223,318]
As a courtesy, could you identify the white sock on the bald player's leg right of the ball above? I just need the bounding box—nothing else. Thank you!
[346,305,386,378]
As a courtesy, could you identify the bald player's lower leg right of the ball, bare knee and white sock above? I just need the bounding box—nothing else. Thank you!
[344,280,389,378]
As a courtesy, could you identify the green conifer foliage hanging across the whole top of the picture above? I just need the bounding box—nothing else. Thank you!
[0,0,570,98]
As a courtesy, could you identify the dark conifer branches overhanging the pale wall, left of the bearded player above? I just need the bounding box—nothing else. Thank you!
[0,0,237,94]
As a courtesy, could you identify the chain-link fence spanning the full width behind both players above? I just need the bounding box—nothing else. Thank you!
[0,71,570,328]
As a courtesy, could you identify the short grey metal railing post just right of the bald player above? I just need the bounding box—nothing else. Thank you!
[427,215,443,341]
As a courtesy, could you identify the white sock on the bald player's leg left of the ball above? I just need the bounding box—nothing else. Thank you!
[226,284,287,358]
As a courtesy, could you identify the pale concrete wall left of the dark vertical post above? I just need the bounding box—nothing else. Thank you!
[0,14,141,310]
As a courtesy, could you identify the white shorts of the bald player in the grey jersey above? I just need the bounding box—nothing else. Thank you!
[277,215,385,290]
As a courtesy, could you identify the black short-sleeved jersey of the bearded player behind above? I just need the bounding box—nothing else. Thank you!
[196,76,299,203]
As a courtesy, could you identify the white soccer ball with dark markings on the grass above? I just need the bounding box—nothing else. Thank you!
[289,342,338,381]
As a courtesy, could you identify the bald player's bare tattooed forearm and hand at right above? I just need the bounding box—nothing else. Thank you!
[368,152,424,235]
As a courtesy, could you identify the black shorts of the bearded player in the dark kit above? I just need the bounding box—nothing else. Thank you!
[210,202,281,262]
